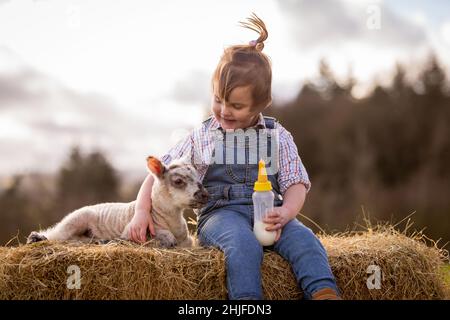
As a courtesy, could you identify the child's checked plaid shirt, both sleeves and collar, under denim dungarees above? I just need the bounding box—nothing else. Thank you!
[161,113,311,195]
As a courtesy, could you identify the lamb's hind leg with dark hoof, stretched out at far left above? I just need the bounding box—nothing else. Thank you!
[27,208,95,243]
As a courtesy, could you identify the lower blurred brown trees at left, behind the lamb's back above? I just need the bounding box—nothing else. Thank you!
[0,147,137,245]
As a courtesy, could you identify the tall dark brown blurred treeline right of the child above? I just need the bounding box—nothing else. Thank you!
[270,56,450,240]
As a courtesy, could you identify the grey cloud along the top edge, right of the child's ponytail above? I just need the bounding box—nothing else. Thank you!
[278,0,427,49]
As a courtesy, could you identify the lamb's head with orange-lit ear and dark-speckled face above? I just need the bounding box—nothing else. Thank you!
[147,156,209,208]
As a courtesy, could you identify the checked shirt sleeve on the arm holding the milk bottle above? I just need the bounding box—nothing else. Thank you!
[278,125,311,194]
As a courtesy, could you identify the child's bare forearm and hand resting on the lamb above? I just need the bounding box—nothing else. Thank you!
[130,174,155,242]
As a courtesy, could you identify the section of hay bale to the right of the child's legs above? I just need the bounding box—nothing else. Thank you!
[321,229,448,300]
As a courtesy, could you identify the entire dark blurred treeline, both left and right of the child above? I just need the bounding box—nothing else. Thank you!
[0,57,450,244]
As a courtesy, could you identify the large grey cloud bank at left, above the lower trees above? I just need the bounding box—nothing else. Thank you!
[0,47,179,173]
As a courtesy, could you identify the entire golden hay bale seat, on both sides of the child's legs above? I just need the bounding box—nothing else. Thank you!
[0,229,448,299]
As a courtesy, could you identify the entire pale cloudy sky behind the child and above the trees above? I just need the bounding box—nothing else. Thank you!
[0,0,450,180]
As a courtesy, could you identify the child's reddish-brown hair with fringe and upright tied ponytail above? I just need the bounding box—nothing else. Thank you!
[212,13,272,108]
